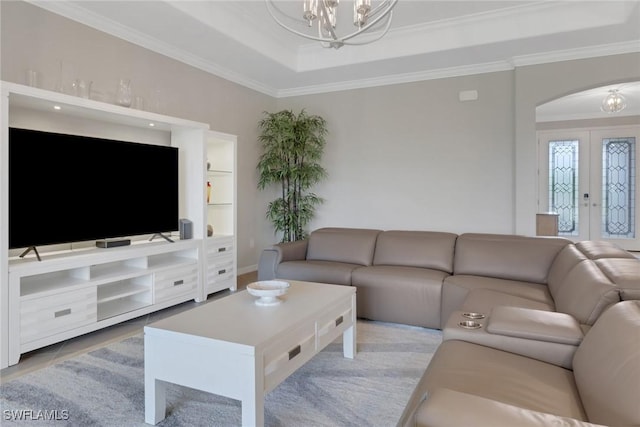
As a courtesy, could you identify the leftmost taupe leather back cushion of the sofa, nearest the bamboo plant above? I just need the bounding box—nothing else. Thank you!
[307,228,380,265]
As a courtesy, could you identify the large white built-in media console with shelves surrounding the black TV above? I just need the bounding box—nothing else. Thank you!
[0,82,237,368]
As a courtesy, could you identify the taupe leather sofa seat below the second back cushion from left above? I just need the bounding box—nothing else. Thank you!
[351,265,448,328]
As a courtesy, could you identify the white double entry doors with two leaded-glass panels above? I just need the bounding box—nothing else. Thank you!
[538,126,640,250]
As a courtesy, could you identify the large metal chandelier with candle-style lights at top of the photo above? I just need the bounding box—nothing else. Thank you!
[265,0,398,49]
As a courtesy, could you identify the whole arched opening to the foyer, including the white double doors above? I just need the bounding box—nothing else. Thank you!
[536,82,640,250]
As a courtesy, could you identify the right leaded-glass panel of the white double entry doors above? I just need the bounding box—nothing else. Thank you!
[602,138,636,238]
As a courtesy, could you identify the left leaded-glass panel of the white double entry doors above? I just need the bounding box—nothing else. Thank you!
[549,140,579,236]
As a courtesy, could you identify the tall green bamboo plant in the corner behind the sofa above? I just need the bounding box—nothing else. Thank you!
[257,110,327,242]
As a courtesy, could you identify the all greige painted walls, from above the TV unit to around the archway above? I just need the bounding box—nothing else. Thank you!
[0,1,640,269]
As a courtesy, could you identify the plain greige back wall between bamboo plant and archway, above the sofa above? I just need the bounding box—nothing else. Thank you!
[278,72,514,233]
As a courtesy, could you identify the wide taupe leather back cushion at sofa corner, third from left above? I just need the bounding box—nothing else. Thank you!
[453,233,571,283]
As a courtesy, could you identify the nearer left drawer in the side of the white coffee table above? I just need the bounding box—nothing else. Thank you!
[263,323,316,391]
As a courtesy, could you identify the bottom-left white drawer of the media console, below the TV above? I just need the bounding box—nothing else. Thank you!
[20,286,98,344]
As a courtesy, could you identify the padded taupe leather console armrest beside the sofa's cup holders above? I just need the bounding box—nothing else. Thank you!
[487,306,583,346]
